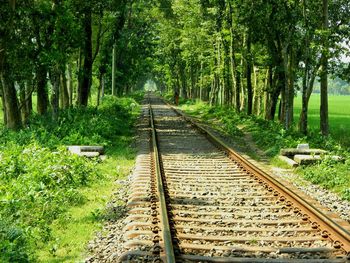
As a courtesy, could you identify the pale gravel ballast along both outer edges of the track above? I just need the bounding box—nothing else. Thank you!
[86,103,350,263]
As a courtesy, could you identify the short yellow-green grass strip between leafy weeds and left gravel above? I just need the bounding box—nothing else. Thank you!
[38,154,134,263]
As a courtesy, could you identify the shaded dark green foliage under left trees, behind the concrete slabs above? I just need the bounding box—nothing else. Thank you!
[0,96,137,149]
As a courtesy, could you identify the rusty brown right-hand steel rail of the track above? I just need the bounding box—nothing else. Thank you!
[165,102,350,256]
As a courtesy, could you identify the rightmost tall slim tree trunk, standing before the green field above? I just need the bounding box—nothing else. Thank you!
[320,0,329,136]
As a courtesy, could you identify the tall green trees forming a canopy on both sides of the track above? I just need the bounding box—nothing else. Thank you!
[0,0,350,135]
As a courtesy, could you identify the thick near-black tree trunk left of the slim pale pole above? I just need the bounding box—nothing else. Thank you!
[78,8,92,106]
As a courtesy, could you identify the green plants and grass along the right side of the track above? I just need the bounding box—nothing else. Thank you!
[176,97,350,200]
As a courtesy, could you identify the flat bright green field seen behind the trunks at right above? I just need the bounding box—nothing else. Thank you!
[294,94,350,145]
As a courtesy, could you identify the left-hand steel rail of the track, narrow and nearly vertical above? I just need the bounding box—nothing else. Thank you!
[148,103,175,263]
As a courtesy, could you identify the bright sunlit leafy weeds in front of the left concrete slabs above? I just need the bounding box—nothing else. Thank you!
[0,144,95,262]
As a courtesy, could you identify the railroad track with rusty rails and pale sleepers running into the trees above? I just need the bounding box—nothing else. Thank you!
[119,96,350,262]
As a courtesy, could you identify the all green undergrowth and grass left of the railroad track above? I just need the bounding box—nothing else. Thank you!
[0,97,139,262]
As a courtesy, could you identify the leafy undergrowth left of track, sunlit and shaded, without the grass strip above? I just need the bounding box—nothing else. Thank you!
[0,96,138,262]
